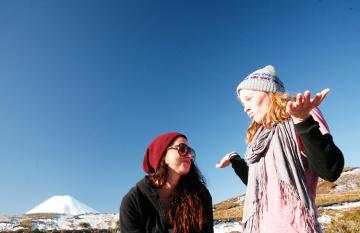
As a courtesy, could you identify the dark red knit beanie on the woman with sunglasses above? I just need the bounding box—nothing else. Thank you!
[143,132,186,174]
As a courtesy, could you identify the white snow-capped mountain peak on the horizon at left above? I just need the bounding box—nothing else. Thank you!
[25,195,98,215]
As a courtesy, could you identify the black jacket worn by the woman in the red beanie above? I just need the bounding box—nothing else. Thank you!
[120,178,214,233]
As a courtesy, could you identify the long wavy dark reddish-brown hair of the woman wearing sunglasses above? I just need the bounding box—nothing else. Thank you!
[147,160,208,233]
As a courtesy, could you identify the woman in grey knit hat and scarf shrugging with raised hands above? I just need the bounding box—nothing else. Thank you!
[216,66,344,233]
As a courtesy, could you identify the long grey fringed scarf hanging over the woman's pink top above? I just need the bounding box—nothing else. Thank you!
[243,118,321,233]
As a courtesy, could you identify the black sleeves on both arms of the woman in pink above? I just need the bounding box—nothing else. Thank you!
[230,116,344,185]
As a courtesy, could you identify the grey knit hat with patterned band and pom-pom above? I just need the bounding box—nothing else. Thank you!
[236,65,285,95]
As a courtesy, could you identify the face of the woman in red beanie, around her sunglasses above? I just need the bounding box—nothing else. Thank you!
[165,137,192,177]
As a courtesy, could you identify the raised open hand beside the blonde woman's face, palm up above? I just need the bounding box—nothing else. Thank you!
[286,88,330,124]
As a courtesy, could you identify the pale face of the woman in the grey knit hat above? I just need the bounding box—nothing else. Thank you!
[239,89,271,124]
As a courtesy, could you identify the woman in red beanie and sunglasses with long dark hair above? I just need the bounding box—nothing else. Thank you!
[120,132,214,233]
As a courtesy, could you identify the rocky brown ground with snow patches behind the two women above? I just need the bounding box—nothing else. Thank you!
[0,168,360,233]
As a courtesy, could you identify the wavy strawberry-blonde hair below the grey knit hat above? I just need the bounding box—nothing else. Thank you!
[246,92,291,143]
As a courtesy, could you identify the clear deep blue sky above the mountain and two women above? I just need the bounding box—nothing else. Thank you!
[0,0,360,215]
